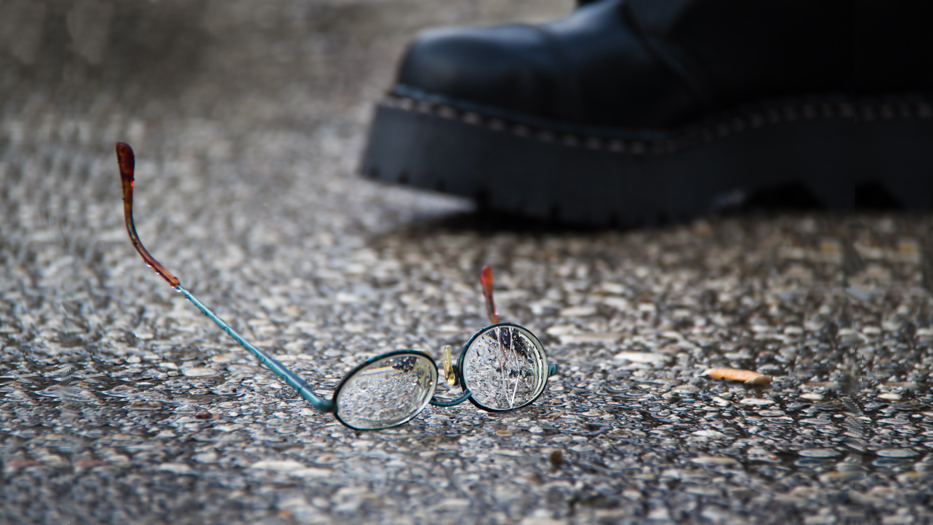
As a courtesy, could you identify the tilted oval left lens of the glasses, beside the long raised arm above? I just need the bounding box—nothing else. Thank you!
[337,355,437,430]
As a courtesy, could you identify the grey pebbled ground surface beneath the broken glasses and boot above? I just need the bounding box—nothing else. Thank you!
[0,0,933,525]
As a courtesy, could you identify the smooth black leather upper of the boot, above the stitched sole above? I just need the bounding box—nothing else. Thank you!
[394,0,933,130]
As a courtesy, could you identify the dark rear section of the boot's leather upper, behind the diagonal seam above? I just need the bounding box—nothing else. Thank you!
[627,0,933,106]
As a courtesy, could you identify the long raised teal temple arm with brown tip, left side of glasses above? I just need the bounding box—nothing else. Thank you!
[117,142,337,412]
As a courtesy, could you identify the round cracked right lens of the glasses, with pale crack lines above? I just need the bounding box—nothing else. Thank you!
[463,326,547,410]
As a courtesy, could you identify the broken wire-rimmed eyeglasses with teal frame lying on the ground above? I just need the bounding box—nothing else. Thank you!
[117,142,557,430]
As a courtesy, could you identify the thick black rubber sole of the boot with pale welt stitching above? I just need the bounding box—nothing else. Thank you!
[361,95,933,226]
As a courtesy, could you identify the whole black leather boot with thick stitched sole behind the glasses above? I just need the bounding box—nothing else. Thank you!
[363,0,933,225]
